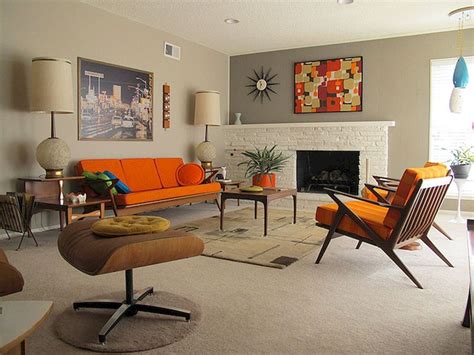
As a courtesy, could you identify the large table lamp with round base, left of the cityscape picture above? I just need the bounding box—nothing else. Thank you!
[31,57,74,178]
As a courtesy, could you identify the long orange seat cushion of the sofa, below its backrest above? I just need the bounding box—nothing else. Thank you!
[115,182,221,206]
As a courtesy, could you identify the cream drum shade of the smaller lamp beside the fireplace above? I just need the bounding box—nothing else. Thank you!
[194,91,221,126]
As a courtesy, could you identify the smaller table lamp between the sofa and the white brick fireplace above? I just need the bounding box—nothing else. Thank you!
[194,90,221,169]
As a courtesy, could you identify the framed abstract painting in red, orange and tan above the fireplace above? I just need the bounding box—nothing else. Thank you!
[294,57,362,113]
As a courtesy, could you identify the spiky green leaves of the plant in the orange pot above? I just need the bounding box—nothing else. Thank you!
[238,145,290,177]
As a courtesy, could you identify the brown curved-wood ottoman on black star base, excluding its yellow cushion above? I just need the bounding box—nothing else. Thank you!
[58,221,204,343]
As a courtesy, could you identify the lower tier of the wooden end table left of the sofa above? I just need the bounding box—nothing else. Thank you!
[36,197,110,230]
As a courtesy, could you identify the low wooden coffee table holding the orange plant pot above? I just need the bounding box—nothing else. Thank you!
[220,188,296,236]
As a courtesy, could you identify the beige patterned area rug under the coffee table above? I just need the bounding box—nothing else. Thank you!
[173,207,327,269]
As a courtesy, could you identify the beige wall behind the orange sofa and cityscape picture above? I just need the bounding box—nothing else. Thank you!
[0,0,229,227]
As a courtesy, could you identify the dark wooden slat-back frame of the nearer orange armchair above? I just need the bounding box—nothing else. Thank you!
[315,176,453,289]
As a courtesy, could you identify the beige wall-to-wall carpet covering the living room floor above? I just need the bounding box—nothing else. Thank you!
[0,203,472,355]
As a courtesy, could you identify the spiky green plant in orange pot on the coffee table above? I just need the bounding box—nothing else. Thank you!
[239,145,289,187]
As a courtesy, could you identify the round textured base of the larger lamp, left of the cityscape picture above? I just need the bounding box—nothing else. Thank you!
[36,138,71,178]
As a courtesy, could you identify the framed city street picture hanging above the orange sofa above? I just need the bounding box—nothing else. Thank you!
[77,58,153,141]
